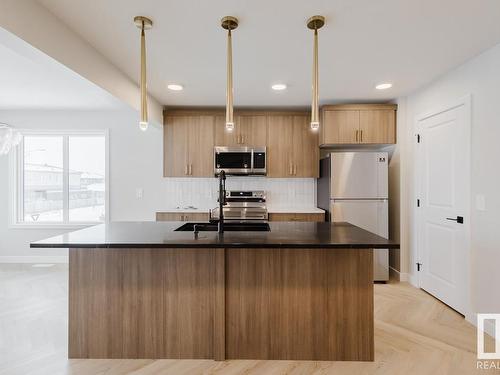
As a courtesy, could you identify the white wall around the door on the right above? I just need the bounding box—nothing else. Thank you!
[400,45,500,313]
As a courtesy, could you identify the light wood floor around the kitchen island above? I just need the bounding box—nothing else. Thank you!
[0,265,499,375]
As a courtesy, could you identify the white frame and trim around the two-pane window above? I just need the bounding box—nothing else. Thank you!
[9,129,110,229]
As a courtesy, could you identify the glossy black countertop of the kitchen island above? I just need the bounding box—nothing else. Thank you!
[30,221,399,249]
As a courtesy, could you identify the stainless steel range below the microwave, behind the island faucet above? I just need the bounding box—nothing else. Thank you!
[210,190,268,222]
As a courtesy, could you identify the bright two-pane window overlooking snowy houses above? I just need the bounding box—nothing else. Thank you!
[14,132,107,225]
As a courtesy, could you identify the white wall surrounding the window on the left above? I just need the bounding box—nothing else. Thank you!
[0,109,164,261]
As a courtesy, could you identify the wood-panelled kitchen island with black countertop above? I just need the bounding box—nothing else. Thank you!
[31,222,399,361]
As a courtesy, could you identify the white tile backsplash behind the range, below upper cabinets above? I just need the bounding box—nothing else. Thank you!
[161,176,316,209]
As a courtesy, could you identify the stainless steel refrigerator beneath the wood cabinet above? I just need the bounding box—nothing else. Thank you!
[317,152,389,281]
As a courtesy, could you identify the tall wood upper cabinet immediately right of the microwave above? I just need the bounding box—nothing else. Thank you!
[267,114,319,177]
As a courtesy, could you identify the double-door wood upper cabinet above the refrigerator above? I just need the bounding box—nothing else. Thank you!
[320,104,397,145]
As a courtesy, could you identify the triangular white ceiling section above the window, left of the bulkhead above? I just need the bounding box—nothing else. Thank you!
[0,29,123,110]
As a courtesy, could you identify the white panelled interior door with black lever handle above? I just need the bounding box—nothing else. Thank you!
[416,101,470,314]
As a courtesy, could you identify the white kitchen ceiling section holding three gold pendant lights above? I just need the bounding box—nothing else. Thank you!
[39,0,500,107]
